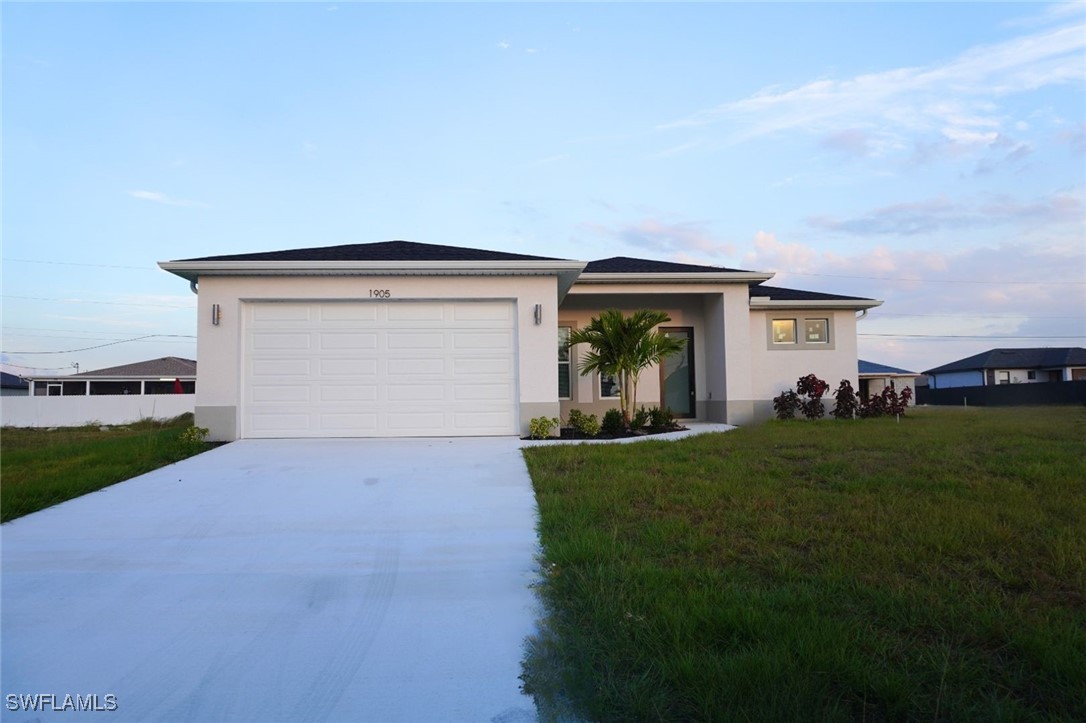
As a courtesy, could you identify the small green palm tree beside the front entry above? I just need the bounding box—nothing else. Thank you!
[569,308,686,427]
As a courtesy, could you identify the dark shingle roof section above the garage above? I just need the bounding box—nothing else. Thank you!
[182,241,561,262]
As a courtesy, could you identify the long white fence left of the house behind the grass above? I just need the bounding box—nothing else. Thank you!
[0,394,195,427]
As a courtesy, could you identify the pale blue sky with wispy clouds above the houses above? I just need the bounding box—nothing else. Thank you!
[0,1,1086,375]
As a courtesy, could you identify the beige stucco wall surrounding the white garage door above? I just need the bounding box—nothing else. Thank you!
[195,271,558,441]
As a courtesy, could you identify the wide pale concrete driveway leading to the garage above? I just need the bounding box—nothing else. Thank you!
[0,437,536,723]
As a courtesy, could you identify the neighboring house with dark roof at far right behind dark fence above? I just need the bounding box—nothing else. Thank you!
[924,346,1086,390]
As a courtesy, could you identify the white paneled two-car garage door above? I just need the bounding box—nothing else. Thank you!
[241,302,518,437]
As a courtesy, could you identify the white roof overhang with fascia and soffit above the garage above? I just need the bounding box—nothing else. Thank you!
[159,261,585,301]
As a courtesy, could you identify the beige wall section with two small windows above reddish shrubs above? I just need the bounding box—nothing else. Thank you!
[749,308,859,408]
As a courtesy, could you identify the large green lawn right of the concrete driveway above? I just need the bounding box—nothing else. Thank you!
[522,407,1086,721]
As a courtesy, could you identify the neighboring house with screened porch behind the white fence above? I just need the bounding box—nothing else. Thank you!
[29,356,197,396]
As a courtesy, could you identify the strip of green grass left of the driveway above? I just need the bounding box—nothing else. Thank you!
[0,415,212,522]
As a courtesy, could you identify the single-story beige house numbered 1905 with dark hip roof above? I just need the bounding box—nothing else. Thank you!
[160,241,882,440]
